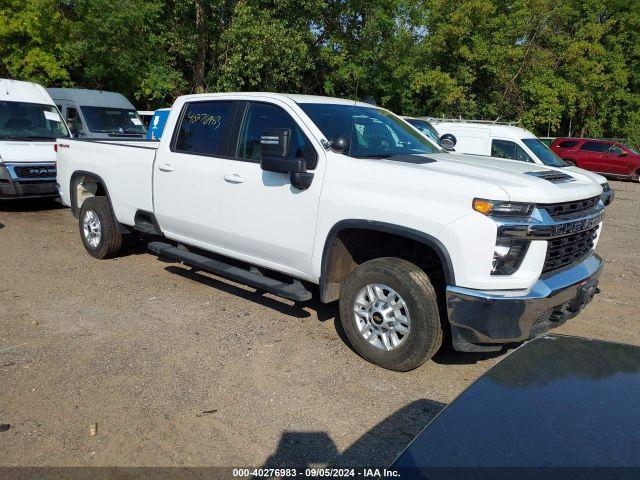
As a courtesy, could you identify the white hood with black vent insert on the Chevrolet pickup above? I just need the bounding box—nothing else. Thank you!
[389,153,602,203]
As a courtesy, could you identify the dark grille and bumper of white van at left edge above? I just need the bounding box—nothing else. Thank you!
[0,163,58,200]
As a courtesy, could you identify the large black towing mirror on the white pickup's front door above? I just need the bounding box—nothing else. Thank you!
[260,128,313,190]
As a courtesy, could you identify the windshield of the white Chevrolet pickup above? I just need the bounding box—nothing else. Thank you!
[300,103,440,158]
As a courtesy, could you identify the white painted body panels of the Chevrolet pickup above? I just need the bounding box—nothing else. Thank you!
[58,93,602,290]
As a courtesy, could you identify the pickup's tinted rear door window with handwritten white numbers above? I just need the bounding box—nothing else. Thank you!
[172,101,236,156]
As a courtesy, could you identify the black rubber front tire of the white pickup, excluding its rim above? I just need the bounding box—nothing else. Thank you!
[340,257,442,372]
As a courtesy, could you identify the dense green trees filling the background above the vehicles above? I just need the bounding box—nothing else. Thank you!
[0,0,640,145]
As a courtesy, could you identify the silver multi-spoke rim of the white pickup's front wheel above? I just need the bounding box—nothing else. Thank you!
[353,283,411,351]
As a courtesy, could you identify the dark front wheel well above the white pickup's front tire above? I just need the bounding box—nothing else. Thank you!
[320,228,452,303]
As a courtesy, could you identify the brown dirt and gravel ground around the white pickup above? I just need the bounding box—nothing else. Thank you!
[0,182,640,467]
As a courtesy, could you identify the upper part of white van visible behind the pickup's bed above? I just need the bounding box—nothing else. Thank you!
[47,88,147,139]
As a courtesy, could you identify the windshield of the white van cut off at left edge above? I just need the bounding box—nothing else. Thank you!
[0,101,69,140]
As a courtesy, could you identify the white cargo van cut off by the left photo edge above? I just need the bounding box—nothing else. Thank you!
[0,79,69,200]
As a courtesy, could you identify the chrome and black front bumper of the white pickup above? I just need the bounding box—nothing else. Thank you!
[446,253,603,352]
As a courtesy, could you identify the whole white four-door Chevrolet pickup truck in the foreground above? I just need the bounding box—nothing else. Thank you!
[57,93,604,370]
